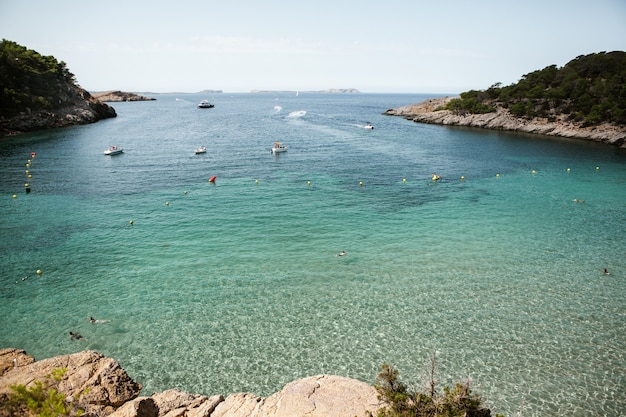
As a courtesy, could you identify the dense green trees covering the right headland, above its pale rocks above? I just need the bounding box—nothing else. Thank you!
[444,51,626,126]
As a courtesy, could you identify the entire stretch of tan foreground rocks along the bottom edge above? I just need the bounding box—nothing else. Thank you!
[0,348,382,417]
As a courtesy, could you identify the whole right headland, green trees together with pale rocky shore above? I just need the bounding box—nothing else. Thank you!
[383,51,626,148]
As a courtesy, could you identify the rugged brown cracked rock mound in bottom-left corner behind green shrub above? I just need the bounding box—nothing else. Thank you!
[0,351,141,414]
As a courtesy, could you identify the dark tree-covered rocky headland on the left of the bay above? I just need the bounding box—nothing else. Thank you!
[0,39,116,132]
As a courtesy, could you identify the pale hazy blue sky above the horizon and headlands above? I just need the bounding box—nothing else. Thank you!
[0,0,626,93]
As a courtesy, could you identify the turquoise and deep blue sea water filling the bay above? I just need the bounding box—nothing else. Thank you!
[0,92,626,417]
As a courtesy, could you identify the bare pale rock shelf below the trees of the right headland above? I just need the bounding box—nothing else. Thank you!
[383,97,626,149]
